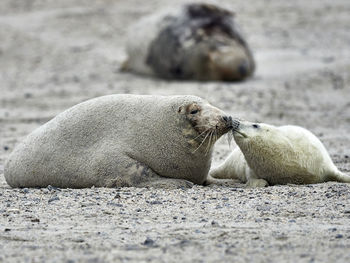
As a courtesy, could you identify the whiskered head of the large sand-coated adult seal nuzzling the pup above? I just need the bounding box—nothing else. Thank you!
[177,99,233,154]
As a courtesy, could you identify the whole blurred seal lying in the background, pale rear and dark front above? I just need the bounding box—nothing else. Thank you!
[122,3,255,81]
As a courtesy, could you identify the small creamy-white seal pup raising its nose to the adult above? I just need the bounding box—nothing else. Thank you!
[210,120,350,187]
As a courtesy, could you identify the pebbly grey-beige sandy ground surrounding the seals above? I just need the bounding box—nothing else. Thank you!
[0,0,350,262]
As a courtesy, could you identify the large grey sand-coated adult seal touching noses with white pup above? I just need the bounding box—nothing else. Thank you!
[4,95,232,188]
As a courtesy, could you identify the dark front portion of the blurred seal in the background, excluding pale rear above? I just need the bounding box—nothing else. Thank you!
[146,4,255,81]
